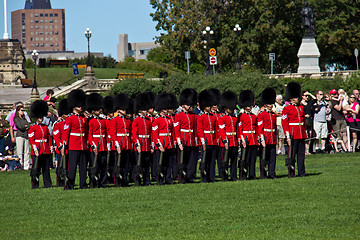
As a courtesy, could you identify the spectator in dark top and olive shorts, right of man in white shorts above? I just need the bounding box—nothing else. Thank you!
[330,89,347,150]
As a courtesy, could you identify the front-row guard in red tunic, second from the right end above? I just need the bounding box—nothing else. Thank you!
[256,88,277,179]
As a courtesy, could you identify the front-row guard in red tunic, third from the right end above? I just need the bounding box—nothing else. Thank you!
[238,90,258,180]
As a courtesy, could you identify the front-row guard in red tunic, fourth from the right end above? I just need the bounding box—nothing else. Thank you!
[218,91,239,181]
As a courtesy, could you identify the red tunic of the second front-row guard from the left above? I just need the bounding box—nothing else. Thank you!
[63,113,88,150]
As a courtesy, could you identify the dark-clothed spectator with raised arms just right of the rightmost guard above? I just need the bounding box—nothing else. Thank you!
[300,91,316,155]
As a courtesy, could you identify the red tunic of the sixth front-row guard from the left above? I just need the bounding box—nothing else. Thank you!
[152,116,174,150]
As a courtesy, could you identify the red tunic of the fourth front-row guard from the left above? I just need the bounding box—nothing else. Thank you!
[110,115,132,150]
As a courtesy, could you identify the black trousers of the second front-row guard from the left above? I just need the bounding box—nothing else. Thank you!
[65,150,88,190]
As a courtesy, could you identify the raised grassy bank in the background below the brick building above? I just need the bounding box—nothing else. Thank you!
[26,67,154,87]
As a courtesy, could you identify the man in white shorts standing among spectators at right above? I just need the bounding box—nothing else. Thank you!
[312,90,329,153]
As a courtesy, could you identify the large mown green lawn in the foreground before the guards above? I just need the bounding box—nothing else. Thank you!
[0,153,360,239]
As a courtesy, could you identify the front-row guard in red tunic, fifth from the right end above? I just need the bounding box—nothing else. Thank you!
[196,90,218,182]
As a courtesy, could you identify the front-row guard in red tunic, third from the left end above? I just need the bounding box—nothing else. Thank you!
[86,93,108,188]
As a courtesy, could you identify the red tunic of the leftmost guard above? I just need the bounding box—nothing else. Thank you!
[29,123,52,155]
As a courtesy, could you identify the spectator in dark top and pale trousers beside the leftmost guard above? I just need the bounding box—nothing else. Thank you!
[14,106,30,170]
